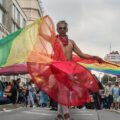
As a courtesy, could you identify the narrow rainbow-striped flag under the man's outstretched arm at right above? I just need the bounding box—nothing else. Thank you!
[73,55,120,75]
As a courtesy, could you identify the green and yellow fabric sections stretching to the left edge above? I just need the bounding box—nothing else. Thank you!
[0,17,44,67]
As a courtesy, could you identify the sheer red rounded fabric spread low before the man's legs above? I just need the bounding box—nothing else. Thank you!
[28,62,99,106]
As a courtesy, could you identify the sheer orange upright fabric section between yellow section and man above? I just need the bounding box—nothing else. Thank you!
[27,16,56,63]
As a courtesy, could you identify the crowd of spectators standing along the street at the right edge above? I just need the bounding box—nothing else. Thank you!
[86,81,120,110]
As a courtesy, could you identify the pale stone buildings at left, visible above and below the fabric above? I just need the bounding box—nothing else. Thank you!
[0,0,42,83]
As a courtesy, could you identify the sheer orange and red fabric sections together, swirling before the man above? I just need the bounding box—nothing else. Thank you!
[27,17,99,106]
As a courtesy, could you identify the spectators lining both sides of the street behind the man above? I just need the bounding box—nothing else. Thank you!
[0,78,120,110]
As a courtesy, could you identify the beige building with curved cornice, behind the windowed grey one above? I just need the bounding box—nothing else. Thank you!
[17,0,43,24]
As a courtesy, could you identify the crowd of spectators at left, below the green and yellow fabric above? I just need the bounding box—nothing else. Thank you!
[0,78,49,107]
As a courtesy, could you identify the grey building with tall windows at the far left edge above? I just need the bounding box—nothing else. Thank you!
[0,0,27,38]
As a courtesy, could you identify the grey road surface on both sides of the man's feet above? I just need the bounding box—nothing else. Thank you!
[0,108,120,120]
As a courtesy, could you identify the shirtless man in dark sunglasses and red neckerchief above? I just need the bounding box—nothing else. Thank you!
[56,21,101,120]
